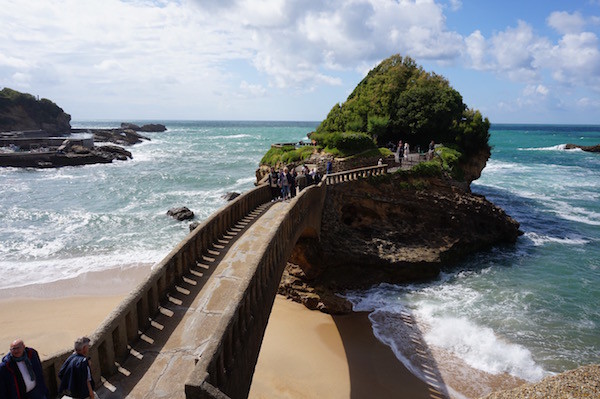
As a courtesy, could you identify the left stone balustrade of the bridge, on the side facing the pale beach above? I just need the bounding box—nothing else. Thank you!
[42,185,271,397]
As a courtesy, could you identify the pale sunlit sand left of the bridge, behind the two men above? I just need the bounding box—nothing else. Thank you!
[0,265,150,358]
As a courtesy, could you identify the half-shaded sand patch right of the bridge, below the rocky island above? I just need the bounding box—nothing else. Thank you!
[249,296,431,399]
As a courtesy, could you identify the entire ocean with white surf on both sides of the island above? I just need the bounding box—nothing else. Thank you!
[0,121,600,396]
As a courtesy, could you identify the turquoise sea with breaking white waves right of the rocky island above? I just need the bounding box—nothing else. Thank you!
[350,125,600,388]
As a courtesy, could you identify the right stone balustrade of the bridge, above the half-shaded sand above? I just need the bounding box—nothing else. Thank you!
[185,182,326,399]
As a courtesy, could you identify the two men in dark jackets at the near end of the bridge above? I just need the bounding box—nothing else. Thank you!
[0,337,97,399]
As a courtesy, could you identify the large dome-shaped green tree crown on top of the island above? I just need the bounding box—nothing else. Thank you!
[311,54,490,157]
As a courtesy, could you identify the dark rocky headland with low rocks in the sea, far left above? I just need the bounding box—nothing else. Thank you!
[0,88,166,168]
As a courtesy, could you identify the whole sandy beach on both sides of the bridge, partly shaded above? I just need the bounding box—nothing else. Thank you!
[0,268,430,399]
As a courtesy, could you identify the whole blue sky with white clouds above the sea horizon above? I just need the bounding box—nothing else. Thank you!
[0,0,600,124]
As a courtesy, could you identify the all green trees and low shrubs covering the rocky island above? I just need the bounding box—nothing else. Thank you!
[261,54,490,180]
